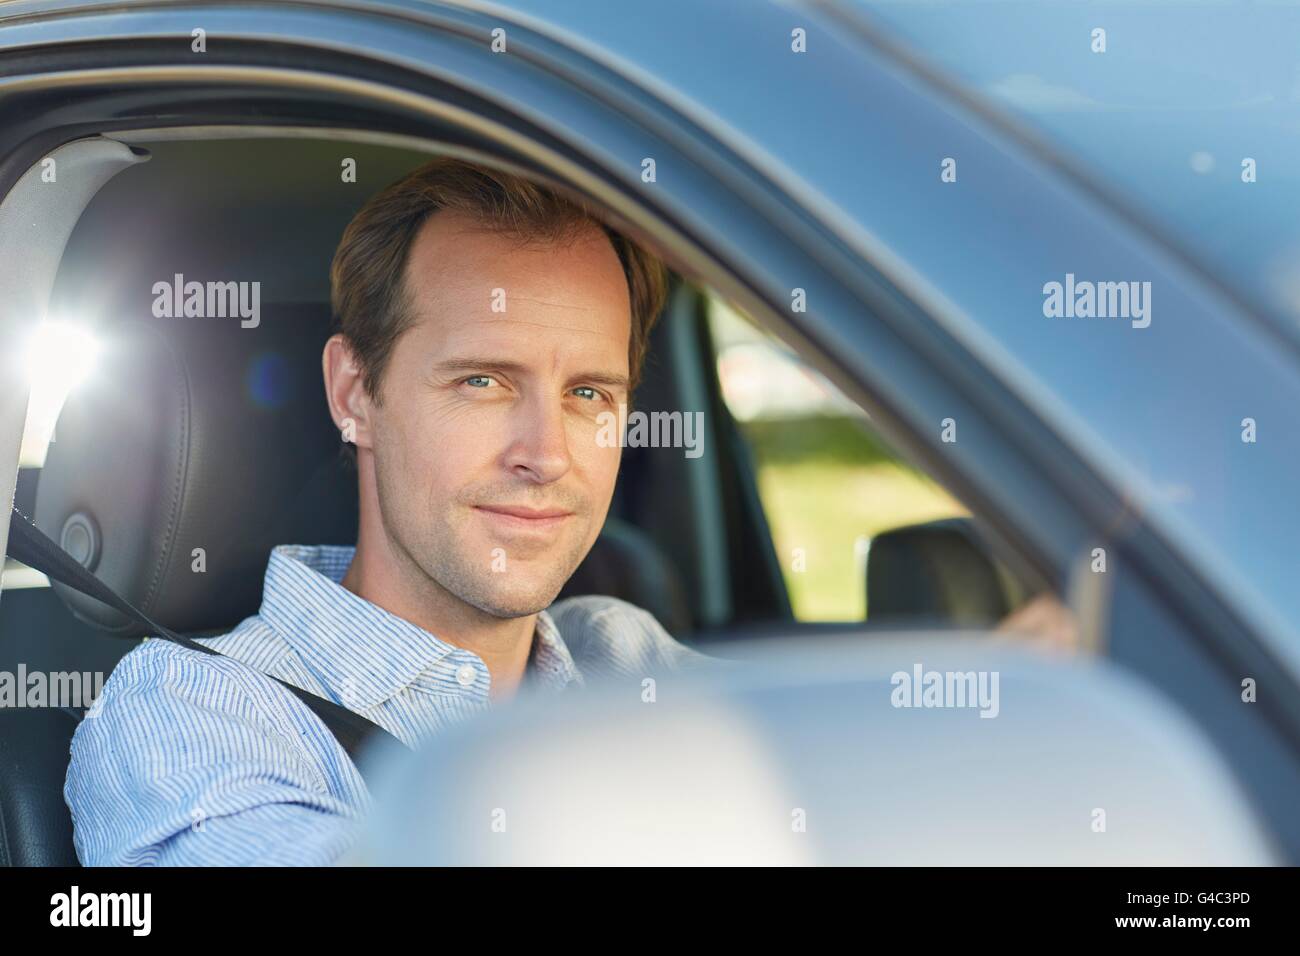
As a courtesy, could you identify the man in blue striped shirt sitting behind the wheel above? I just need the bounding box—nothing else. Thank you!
[64,160,1076,865]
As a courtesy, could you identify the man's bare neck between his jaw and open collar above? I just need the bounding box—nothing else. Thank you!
[341,533,537,700]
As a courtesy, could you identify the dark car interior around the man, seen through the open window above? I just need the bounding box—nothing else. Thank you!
[0,134,1043,865]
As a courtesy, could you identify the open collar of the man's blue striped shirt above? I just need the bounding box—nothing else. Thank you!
[261,545,581,710]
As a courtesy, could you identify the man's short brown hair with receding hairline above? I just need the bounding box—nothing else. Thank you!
[330,157,668,416]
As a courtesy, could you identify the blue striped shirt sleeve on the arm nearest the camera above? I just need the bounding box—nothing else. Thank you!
[64,640,369,866]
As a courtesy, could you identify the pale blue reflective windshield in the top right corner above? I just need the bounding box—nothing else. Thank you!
[850,0,1300,341]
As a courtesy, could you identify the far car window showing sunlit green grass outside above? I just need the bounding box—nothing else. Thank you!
[707,298,969,622]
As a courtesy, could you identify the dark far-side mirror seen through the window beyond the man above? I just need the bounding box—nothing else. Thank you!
[867,518,1023,627]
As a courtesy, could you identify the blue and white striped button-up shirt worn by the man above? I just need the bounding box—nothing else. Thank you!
[64,545,710,866]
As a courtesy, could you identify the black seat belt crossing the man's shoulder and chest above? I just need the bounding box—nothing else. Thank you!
[8,506,397,762]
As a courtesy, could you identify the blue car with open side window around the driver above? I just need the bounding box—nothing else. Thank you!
[0,0,1300,865]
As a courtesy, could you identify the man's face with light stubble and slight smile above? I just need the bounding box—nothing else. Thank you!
[373,213,631,618]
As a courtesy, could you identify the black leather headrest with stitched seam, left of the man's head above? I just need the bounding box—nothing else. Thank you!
[35,306,356,636]
